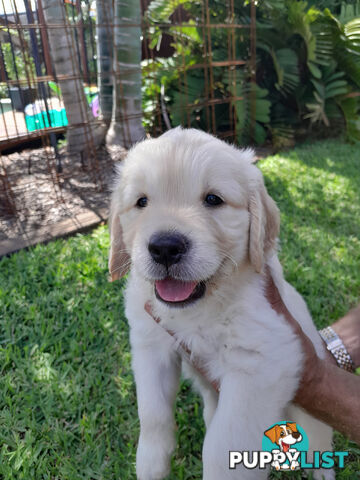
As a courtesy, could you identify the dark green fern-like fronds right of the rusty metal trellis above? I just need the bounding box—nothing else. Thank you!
[258,0,360,144]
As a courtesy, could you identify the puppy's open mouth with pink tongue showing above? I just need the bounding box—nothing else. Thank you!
[155,277,206,307]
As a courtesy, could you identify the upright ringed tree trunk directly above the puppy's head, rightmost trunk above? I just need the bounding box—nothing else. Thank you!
[106,0,145,148]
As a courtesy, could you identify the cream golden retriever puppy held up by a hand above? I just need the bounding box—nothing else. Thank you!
[109,128,334,480]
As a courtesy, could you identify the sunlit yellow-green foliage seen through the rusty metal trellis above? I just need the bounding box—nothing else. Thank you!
[143,0,252,141]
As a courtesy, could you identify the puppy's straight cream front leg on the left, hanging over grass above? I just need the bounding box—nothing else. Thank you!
[132,340,180,480]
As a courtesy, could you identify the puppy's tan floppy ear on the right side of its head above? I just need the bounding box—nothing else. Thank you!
[249,178,280,273]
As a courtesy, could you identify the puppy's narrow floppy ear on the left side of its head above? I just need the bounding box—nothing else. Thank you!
[109,206,130,282]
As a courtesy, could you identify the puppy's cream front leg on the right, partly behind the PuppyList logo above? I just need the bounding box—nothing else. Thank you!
[203,372,288,480]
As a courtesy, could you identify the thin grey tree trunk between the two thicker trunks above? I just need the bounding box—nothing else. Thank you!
[96,0,114,125]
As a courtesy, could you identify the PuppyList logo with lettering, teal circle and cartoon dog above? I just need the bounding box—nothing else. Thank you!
[229,421,349,471]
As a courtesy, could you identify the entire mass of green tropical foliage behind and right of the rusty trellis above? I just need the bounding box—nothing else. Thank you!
[144,0,360,148]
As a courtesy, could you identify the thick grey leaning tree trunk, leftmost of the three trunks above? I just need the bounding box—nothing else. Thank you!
[43,0,105,153]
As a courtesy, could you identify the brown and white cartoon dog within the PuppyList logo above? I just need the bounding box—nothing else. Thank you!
[264,422,303,470]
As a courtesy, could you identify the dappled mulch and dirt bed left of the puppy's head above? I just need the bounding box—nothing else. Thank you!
[0,147,125,246]
